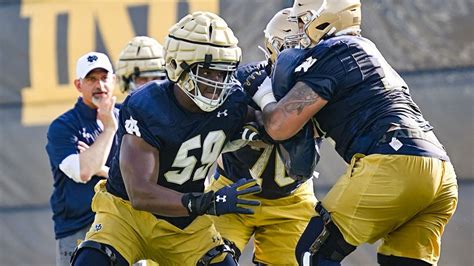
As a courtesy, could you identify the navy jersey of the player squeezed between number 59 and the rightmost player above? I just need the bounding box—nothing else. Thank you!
[218,61,319,199]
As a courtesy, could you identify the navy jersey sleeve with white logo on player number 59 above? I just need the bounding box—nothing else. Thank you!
[119,97,161,149]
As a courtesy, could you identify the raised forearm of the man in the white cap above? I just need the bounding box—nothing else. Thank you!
[79,128,115,181]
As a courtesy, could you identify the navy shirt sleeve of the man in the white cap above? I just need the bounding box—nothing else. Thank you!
[46,120,78,167]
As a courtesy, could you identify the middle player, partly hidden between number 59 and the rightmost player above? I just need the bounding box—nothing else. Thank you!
[211,8,318,265]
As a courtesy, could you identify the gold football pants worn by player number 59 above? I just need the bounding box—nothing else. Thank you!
[86,180,225,265]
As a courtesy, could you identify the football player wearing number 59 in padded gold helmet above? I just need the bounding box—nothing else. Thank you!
[72,12,260,265]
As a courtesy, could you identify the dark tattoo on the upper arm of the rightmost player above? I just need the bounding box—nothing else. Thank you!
[281,82,320,115]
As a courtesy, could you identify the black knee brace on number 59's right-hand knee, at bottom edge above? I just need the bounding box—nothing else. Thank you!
[197,239,240,266]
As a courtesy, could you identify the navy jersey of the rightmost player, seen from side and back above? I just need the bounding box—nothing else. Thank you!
[272,36,444,162]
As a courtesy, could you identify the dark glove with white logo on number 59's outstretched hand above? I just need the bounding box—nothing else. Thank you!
[181,179,262,216]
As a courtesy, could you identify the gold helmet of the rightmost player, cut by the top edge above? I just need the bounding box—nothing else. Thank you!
[289,0,362,48]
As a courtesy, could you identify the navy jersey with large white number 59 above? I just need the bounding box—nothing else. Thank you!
[107,81,247,220]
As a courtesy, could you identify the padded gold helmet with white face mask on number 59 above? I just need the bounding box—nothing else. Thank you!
[164,12,242,112]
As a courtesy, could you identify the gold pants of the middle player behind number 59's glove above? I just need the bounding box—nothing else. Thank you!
[209,176,316,265]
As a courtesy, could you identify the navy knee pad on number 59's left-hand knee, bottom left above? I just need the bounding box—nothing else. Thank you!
[71,240,128,266]
